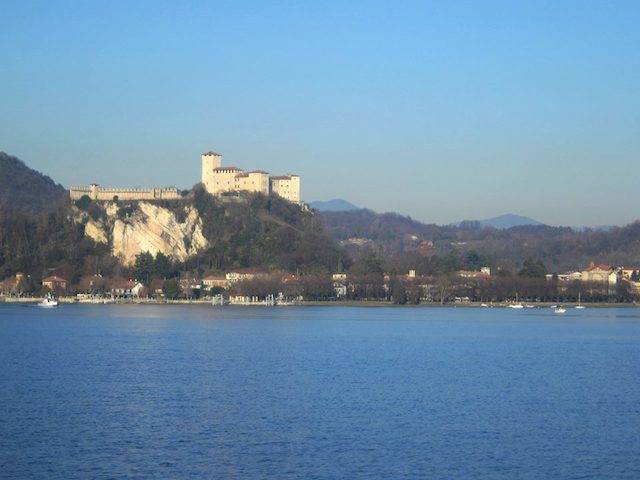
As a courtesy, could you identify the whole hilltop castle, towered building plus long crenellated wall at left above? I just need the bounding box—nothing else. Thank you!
[69,152,300,203]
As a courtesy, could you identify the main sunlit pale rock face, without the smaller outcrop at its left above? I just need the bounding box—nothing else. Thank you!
[112,202,207,265]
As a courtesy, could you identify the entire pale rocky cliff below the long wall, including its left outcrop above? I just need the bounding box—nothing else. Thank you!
[75,202,208,266]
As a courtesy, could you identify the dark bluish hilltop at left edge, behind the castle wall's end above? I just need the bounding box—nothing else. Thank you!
[0,152,67,213]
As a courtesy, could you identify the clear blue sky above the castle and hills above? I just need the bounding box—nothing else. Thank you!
[0,0,640,225]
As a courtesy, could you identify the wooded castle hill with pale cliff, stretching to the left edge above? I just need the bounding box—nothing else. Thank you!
[0,154,346,283]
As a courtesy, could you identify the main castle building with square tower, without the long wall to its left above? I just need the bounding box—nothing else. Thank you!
[201,152,300,203]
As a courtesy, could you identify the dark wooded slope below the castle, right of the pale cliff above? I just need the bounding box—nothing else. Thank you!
[186,187,349,272]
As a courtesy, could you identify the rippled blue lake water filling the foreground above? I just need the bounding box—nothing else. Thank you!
[0,305,640,479]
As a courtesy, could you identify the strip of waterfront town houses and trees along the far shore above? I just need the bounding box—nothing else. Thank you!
[0,264,640,305]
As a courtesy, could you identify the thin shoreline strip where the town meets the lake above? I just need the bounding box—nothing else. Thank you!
[0,297,640,310]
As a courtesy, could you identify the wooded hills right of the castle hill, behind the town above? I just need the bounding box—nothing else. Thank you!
[321,210,640,272]
